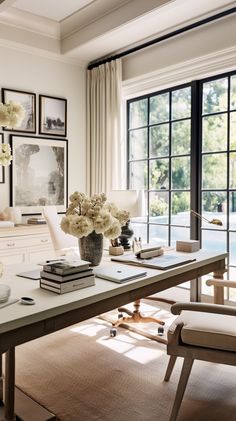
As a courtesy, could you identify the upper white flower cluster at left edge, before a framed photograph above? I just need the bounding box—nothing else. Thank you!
[0,101,25,129]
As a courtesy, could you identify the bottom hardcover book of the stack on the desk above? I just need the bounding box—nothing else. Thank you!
[40,275,95,294]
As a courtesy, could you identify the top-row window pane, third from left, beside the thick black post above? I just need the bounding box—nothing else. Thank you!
[172,87,191,120]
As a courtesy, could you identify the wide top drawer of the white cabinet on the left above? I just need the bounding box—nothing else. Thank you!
[0,235,51,250]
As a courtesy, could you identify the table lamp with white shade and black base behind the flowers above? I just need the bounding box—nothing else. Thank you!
[108,190,144,250]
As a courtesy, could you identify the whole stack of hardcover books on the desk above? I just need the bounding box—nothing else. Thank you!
[40,260,95,294]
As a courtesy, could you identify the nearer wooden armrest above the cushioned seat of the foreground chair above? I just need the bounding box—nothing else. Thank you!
[171,303,236,316]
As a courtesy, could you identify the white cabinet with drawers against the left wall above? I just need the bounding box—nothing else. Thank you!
[0,225,56,265]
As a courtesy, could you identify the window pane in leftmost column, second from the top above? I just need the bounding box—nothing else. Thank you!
[129,129,147,159]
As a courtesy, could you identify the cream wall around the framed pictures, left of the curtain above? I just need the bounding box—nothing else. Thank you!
[0,46,86,212]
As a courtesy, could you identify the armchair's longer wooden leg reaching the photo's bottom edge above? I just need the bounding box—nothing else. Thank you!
[169,357,194,421]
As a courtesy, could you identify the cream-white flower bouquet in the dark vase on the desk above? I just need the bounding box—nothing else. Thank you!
[61,192,129,240]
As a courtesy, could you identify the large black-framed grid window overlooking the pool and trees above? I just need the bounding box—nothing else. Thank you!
[127,68,236,299]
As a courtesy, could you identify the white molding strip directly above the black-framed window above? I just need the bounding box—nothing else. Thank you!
[122,47,236,99]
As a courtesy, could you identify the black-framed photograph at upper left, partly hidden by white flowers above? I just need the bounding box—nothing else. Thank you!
[2,88,36,133]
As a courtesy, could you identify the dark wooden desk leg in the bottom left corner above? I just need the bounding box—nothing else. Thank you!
[4,348,15,420]
